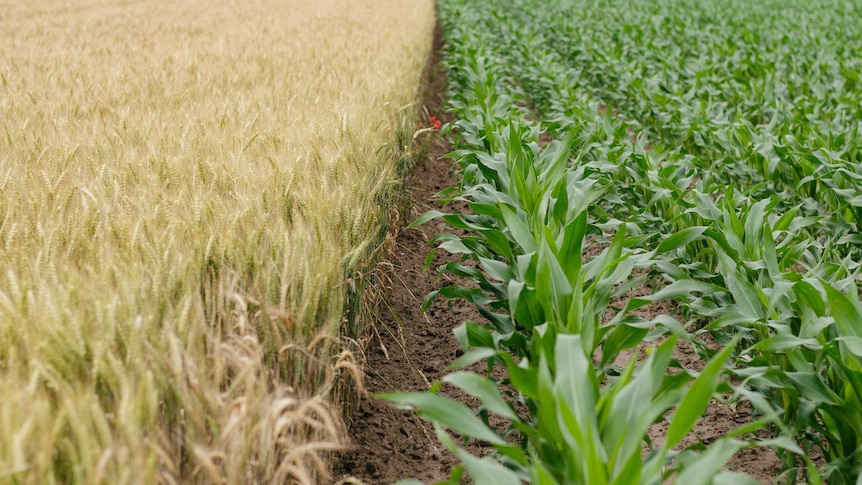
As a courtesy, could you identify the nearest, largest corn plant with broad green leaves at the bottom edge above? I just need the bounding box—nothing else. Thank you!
[387,332,780,485]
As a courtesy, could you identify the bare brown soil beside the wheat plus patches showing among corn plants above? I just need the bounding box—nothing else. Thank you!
[334,20,780,485]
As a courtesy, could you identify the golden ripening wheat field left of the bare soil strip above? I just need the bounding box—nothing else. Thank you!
[0,0,434,484]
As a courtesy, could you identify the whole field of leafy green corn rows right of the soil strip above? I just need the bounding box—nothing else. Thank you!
[396,0,862,485]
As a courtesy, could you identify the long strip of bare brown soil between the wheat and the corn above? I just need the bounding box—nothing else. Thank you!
[336,20,472,484]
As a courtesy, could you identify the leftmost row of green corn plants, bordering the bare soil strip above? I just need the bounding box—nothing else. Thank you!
[387,5,795,478]
